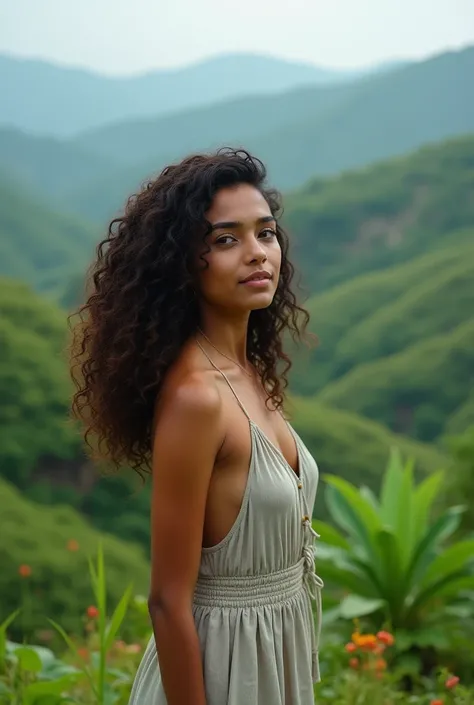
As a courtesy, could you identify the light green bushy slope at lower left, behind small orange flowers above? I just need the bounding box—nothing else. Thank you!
[0,480,149,635]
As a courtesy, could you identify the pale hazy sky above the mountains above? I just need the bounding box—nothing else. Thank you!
[0,0,474,73]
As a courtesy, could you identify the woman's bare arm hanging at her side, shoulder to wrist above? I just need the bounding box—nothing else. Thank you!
[149,378,222,705]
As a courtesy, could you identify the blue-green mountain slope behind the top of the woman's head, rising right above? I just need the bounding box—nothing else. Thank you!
[64,47,474,220]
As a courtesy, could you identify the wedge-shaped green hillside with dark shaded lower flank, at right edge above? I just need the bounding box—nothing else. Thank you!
[318,320,474,441]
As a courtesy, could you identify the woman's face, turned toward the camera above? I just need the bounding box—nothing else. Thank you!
[198,184,281,312]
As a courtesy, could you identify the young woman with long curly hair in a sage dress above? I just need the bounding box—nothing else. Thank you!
[69,150,322,705]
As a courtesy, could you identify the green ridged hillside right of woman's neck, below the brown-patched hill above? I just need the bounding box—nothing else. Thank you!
[291,239,474,395]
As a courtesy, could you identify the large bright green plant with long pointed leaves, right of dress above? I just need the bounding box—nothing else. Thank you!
[314,450,474,649]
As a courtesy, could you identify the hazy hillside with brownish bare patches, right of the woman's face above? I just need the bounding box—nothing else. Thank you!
[285,136,474,291]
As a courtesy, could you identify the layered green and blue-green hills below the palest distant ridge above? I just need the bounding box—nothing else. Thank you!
[0,44,474,546]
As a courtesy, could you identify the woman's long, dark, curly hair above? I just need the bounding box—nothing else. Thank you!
[70,149,309,474]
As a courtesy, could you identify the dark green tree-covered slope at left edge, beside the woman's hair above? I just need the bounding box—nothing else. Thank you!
[0,280,81,485]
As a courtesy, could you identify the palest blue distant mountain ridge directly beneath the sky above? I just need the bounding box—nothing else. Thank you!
[0,54,374,137]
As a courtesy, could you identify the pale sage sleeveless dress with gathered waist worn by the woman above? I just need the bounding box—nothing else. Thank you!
[130,350,323,705]
